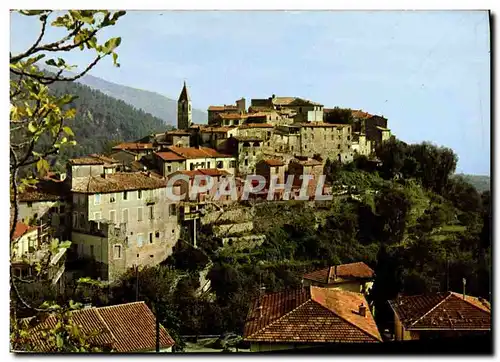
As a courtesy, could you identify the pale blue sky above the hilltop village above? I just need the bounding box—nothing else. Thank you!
[11,11,491,175]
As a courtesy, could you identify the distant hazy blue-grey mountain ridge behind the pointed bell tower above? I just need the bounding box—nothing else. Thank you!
[75,75,207,126]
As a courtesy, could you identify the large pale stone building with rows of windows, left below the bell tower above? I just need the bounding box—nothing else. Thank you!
[69,165,179,278]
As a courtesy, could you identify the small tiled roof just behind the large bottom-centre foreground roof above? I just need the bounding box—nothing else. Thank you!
[303,261,375,284]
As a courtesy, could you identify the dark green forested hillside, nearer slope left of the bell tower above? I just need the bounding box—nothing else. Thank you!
[45,82,167,165]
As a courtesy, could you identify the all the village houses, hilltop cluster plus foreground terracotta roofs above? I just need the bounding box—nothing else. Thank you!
[11,84,490,352]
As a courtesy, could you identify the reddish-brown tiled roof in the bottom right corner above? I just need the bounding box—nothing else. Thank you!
[389,292,491,330]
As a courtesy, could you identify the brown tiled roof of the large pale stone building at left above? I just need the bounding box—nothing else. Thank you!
[71,172,166,194]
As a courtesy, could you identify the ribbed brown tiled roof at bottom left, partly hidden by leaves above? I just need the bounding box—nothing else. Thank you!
[23,302,175,353]
